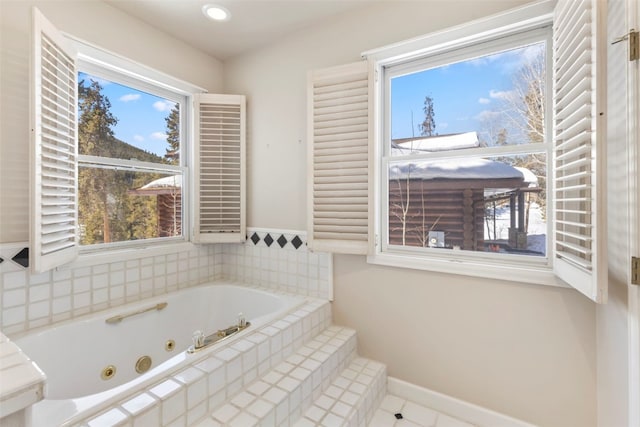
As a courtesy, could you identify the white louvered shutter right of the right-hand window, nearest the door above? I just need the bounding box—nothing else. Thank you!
[553,0,607,302]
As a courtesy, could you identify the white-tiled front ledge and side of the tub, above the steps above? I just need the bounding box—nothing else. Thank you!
[65,298,332,426]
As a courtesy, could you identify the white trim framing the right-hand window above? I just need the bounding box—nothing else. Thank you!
[363,1,570,287]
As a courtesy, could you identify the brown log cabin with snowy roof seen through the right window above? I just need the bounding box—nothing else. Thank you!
[389,159,531,251]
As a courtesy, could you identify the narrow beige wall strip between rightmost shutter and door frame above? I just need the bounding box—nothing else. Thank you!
[596,0,638,427]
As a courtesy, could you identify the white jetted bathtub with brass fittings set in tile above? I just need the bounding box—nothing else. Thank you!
[14,283,304,426]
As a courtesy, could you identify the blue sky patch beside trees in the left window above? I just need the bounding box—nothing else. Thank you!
[78,73,175,156]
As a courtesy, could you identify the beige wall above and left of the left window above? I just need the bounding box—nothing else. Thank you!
[0,0,222,243]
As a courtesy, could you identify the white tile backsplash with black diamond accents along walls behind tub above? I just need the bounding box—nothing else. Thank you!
[0,229,332,336]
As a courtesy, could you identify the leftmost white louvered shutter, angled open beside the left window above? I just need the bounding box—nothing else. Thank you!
[30,8,78,272]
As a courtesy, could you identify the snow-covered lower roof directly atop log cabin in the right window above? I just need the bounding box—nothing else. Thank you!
[389,159,533,180]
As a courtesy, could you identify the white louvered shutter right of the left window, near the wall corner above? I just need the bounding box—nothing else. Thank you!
[193,94,246,243]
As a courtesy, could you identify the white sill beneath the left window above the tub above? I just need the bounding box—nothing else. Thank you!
[68,242,201,268]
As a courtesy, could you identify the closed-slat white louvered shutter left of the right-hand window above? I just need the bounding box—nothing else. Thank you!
[307,61,373,254]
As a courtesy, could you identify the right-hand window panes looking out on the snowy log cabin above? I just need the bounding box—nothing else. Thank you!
[380,30,551,260]
